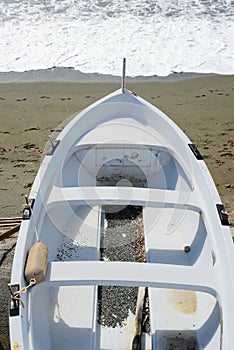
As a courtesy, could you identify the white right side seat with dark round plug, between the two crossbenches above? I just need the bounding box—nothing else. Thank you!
[143,207,209,266]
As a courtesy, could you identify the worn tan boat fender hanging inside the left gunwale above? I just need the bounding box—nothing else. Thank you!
[24,241,48,283]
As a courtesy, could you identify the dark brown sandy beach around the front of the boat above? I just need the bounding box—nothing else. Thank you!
[0,75,234,350]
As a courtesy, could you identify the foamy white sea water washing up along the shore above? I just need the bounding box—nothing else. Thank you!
[0,0,234,76]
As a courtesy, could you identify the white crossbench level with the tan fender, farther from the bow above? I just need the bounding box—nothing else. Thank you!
[45,261,220,296]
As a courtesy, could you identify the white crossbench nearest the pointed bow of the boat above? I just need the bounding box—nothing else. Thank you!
[47,186,201,212]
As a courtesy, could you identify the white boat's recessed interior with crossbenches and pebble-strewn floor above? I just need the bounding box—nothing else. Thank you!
[29,143,222,350]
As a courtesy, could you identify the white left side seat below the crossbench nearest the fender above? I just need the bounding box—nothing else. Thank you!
[30,283,97,349]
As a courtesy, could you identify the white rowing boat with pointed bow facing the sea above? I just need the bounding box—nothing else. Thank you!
[10,64,234,350]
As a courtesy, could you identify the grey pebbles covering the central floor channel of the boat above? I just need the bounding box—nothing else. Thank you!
[98,206,145,328]
